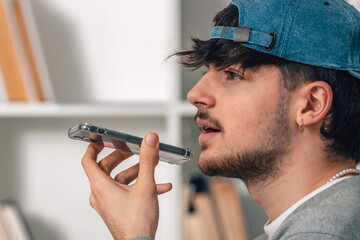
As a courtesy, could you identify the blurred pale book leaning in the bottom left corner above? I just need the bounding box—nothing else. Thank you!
[0,199,34,240]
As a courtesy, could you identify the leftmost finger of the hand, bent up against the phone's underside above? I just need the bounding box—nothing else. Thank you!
[81,143,105,182]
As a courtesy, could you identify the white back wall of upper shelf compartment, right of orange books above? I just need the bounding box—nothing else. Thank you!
[31,0,179,103]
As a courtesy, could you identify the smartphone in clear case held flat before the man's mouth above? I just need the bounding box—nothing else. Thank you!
[68,123,193,165]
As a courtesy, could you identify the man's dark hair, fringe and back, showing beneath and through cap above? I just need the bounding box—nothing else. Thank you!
[174,5,360,163]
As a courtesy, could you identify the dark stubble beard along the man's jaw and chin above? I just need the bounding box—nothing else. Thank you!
[199,93,291,184]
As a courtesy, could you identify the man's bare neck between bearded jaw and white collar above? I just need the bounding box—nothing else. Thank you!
[246,155,355,221]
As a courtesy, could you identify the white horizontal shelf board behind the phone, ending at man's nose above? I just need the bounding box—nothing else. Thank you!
[0,102,196,119]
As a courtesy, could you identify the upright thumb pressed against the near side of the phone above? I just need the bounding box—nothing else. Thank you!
[138,133,159,183]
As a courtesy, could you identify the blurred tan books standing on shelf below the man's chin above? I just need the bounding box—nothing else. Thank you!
[183,177,248,240]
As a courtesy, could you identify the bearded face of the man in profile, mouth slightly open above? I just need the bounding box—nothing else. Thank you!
[188,65,290,182]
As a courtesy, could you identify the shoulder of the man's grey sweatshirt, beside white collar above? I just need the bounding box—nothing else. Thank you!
[274,176,360,240]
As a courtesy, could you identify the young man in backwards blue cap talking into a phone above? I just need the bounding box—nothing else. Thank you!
[82,0,360,239]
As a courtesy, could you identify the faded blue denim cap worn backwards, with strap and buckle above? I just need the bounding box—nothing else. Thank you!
[210,0,360,79]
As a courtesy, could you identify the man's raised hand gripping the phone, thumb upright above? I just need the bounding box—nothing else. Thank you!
[82,133,172,240]
